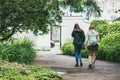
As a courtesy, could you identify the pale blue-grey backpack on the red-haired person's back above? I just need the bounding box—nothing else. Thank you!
[88,32,97,46]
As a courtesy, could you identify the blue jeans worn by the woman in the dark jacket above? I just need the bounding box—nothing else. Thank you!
[74,44,82,64]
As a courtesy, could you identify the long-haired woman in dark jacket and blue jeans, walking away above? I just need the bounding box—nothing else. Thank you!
[71,23,85,67]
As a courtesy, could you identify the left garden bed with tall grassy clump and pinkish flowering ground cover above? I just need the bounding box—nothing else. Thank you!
[0,38,62,80]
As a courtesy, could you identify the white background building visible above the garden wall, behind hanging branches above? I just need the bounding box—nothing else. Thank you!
[63,0,120,22]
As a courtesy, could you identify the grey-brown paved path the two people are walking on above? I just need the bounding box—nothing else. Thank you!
[31,47,120,80]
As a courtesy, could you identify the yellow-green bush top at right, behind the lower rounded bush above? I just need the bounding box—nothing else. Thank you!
[90,20,120,39]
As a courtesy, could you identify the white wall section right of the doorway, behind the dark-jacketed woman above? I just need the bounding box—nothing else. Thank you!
[61,16,89,45]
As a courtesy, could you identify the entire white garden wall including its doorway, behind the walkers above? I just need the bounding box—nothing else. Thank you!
[14,16,89,50]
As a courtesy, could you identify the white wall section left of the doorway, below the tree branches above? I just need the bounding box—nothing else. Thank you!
[13,31,50,50]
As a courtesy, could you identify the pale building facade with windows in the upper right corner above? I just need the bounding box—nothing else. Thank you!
[97,0,120,21]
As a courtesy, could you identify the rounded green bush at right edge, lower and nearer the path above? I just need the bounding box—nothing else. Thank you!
[97,33,120,62]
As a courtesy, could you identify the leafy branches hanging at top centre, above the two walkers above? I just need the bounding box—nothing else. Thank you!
[60,0,102,20]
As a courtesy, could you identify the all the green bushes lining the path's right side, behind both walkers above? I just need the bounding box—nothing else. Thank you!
[61,20,120,63]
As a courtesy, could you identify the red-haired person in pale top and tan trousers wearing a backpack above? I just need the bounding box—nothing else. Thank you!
[87,26,99,69]
